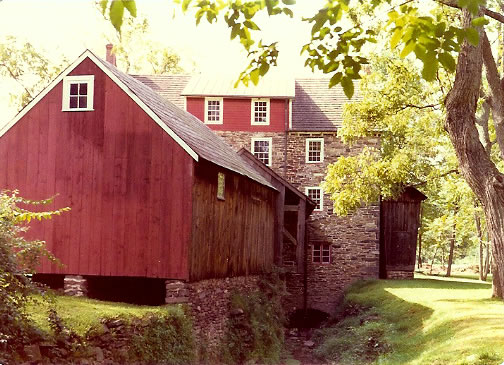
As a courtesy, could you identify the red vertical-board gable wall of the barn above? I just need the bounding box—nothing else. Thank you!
[0,59,194,279]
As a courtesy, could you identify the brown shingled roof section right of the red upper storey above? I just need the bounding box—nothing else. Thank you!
[292,77,362,131]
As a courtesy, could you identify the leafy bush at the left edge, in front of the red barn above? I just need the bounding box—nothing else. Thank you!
[0,191,68,360]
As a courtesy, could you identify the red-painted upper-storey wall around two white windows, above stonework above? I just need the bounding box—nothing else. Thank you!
[187,97,289,132]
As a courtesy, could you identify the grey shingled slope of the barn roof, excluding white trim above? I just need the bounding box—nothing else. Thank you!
[94,56,274,189]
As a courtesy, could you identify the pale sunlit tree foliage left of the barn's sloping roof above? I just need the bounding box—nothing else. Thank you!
[0,36,68,110]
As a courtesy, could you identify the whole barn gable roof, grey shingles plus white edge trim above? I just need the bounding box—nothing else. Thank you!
[0,50,274,189]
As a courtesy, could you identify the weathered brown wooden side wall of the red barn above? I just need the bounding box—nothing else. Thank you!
[189,161,277,280]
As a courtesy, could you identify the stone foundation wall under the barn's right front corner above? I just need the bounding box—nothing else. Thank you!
[166,276,259,359]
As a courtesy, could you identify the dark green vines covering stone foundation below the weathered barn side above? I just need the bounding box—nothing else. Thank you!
[222,273,286,364]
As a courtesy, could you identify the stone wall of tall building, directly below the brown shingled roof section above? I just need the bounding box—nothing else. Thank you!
[287,132,380,313]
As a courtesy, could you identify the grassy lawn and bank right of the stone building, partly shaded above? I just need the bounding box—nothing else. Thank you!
[316,275,504,365]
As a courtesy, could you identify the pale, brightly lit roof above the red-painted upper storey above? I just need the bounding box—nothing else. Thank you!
[181,75,295,99]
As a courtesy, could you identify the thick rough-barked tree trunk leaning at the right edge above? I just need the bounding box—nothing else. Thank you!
[445,11,504,298]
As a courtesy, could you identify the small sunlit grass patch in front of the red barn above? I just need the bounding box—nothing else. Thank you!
[28,295,183,335]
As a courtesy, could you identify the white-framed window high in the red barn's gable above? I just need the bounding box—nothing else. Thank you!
[62,75,94,111]
